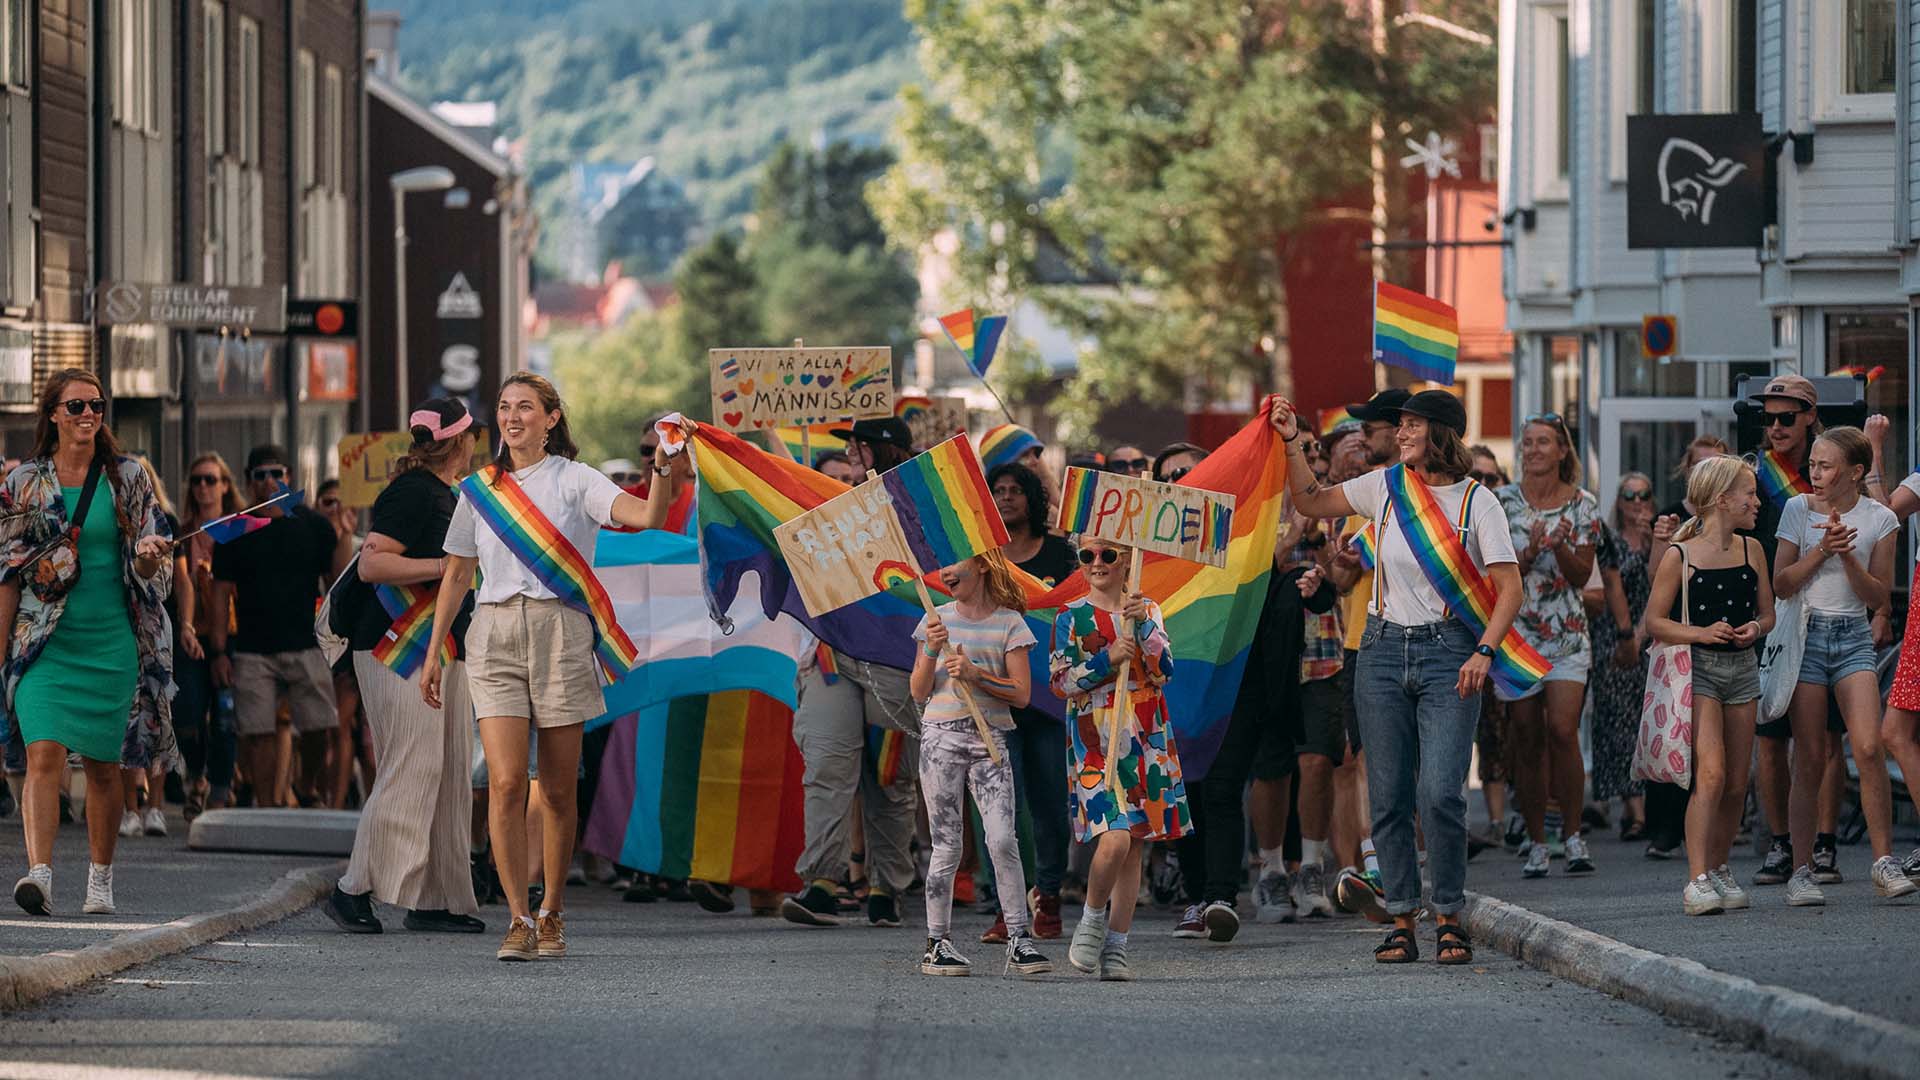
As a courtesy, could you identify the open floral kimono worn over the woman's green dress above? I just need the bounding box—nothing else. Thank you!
[0,457,179,769]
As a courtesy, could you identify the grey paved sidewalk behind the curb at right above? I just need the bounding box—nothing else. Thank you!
[1467,810,1920,1026]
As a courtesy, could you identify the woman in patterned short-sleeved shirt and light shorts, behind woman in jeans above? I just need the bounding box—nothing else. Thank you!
[1498,413,1599,878]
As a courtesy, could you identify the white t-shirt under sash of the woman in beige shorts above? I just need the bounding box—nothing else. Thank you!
[445,455,622,603]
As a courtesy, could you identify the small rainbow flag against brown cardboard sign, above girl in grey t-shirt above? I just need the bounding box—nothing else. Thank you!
[881,434,1008,573]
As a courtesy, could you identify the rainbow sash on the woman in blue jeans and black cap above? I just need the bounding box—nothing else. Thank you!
[1386,465,1553,698]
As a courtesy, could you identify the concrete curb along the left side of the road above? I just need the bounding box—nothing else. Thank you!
[0,863,346,1011]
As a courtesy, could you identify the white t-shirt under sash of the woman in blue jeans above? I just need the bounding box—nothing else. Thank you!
[1340,469,1519,626]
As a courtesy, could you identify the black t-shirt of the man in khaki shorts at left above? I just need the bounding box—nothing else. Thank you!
[213,505,338,653]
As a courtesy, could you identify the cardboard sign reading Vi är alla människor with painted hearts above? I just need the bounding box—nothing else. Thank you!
[707,346,893,430]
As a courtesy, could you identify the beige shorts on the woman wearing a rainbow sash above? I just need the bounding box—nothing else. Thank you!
[467,596,607,728]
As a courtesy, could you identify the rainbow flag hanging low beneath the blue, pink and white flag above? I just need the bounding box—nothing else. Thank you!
[582,690,806,892]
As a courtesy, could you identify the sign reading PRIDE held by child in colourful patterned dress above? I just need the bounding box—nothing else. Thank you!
[1056,469,1233,567]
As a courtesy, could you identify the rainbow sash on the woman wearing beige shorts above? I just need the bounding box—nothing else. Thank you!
[461,465,639,682]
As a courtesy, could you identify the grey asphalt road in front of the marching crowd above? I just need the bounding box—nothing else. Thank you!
[0,868,1803,1080]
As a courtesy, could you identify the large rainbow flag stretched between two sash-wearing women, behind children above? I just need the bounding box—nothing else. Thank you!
[691,405,1286,778]
